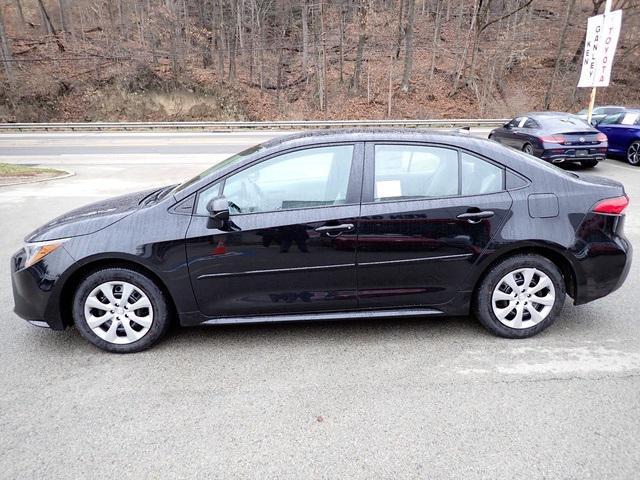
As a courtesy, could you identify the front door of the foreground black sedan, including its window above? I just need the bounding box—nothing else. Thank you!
[187,143,363,317]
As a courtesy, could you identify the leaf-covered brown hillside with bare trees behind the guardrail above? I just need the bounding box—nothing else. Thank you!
[0,0,640,121]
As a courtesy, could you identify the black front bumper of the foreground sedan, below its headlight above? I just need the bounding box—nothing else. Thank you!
[11,247,74,330]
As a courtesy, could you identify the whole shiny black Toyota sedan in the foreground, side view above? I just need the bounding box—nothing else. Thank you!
[11,130,631,352]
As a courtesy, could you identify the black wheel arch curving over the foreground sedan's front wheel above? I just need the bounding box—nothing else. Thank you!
[59,257,178,327]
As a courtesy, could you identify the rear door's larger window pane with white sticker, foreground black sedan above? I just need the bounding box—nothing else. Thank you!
[374,145,458,202]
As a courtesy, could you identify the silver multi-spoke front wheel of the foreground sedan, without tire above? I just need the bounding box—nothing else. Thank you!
[84,281,153,345]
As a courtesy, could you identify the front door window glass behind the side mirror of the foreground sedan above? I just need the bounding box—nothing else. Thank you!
[196,145,354,215]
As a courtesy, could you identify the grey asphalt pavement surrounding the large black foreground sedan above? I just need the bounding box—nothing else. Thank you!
[0,133,640,479]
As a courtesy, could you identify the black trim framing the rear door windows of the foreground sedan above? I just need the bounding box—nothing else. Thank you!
[362,140,508,205]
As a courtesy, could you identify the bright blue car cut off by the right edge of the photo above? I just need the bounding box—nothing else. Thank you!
[596,110,640,165]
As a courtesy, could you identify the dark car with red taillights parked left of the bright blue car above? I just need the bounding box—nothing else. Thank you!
[489,112,607,167]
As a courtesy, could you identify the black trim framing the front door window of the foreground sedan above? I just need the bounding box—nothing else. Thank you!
[192,141,364,217]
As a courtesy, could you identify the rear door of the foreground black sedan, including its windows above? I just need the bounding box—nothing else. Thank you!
[357,143,511,308]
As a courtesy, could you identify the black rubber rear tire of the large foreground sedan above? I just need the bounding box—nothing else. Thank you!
[473,254,566,338]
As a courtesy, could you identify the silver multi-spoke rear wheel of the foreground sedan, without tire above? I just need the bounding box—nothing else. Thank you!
[491,268,556,329]
